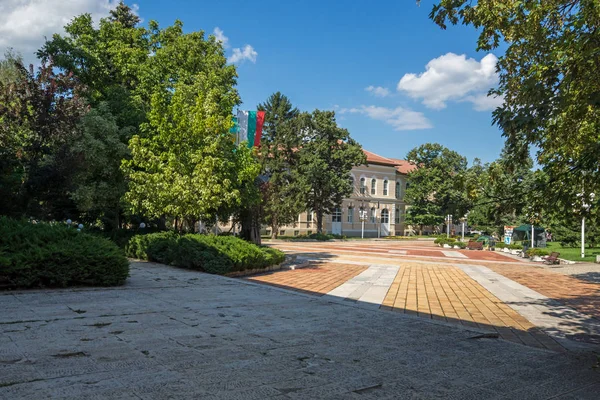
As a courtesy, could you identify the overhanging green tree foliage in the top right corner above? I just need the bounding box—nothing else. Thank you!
[431,0,600,219]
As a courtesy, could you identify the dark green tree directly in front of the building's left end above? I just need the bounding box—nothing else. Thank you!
[298,110,366,233]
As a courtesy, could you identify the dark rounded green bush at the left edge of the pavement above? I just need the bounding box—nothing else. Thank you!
[0,217,129,288]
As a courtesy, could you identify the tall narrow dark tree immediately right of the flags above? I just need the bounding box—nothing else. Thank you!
[258,92,305,238]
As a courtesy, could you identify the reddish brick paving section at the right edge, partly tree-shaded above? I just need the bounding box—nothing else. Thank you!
[486,264,600,319]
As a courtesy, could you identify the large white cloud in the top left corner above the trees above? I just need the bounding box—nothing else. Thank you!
[0,0,138,62]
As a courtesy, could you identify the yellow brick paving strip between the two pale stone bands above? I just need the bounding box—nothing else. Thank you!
[382,263,564,351]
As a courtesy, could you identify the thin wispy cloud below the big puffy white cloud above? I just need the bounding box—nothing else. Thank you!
[340,106,433,131]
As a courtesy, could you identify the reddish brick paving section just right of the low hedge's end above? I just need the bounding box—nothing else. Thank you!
[246,263,368,295]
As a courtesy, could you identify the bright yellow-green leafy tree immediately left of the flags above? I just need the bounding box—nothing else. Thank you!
[123,22,251,228]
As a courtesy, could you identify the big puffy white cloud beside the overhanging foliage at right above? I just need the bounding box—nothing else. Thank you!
[397,53,501,111]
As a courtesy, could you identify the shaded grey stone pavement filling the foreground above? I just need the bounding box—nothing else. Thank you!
[0,263,600,400]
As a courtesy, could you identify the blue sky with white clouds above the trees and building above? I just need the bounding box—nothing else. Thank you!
[0,0,503,162]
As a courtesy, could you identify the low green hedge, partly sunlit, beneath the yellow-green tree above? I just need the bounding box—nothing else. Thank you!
[125,232,285,275]
